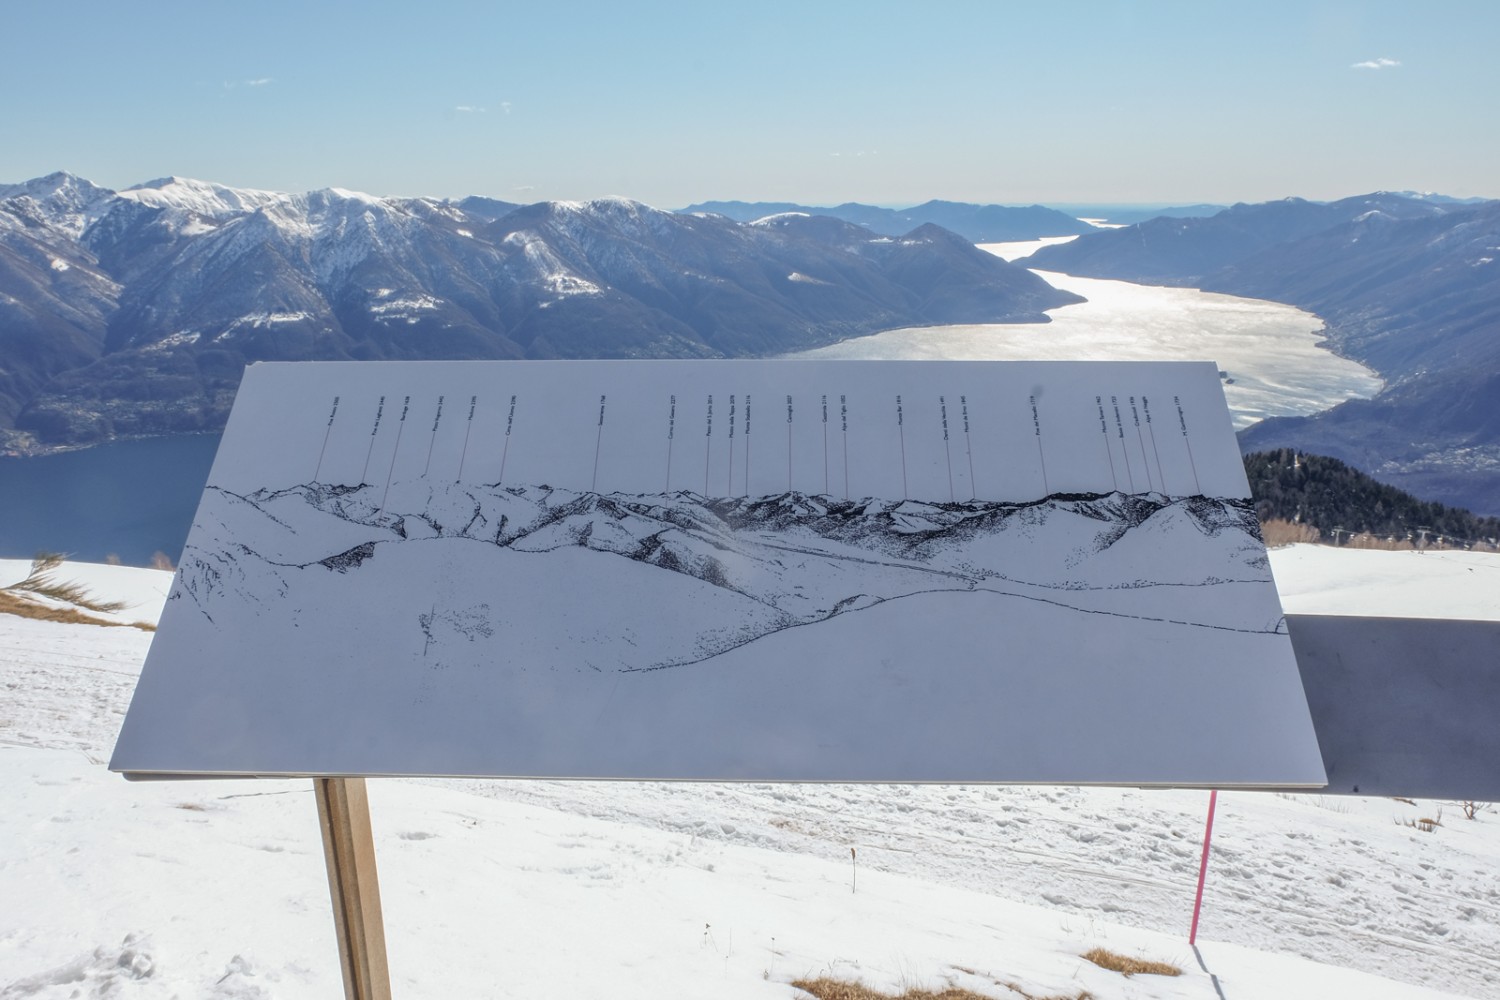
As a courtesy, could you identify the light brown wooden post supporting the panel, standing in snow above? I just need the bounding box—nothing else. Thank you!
[312,778,390,1000]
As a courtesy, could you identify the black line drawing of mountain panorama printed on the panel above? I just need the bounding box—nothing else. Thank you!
[171,480,1281,673]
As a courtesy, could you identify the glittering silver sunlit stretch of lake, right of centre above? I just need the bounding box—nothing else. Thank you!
[794,237,1382,430]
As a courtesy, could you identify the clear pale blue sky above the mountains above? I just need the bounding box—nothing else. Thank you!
[0,0,1500,207]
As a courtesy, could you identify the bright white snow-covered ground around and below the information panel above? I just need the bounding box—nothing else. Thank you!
[0,546,1500,1000]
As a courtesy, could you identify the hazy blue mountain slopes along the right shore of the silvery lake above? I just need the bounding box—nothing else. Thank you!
[1028,193,1500,514]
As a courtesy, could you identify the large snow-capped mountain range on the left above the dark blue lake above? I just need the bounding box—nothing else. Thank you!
[0,174,1079,450]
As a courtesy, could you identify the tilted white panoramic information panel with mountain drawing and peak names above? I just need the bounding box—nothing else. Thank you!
[110,361,1325,787]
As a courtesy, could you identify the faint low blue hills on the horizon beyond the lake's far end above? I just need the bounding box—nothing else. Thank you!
[683,201,1094,243]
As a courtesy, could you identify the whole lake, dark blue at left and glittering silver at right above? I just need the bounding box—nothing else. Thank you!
[0,250,1380,565]
